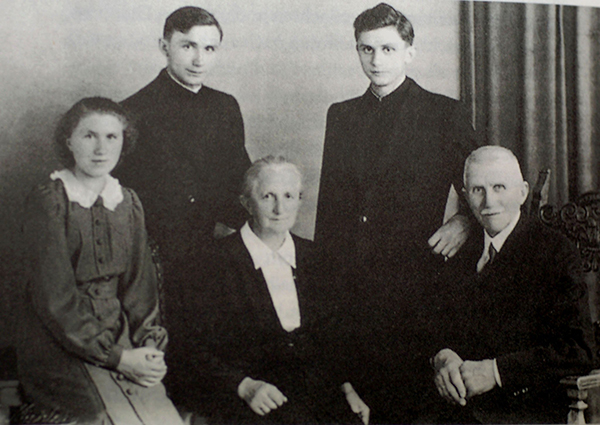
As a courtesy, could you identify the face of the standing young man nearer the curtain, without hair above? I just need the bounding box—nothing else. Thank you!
[356,26,415,96]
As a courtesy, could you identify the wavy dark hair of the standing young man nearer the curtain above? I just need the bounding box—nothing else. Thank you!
[354,3,415,46]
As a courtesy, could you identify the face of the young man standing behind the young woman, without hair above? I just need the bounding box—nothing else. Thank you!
[160,25,221,90]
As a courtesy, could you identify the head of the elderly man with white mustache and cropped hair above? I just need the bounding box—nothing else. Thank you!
[463,146,529,237]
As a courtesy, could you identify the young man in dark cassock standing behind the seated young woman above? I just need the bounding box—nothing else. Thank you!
[116,6,250,410]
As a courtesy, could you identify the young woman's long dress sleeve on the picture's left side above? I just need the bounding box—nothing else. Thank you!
[23,184,122,368]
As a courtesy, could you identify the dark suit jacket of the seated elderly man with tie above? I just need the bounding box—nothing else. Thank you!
[432,217,593,423]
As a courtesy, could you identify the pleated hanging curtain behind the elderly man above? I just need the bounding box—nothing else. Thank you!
[461,1,600,206]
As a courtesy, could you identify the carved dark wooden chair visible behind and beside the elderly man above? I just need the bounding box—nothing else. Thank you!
[529,170,600,424]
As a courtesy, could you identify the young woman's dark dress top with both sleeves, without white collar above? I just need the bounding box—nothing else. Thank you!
[23,181,167,369]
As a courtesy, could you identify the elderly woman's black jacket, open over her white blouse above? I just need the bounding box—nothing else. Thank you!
[176,232,357,423]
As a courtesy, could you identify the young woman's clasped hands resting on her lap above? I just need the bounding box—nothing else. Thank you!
[117,347,167,387]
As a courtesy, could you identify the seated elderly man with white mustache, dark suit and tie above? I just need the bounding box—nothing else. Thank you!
[432,146,592,423]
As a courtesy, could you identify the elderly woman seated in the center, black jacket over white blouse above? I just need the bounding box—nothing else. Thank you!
[178,156,369,424]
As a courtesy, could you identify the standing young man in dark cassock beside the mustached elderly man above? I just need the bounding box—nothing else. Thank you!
[316,3,475,422]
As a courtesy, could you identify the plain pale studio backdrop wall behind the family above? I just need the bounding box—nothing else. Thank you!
[0,0,459,247]
